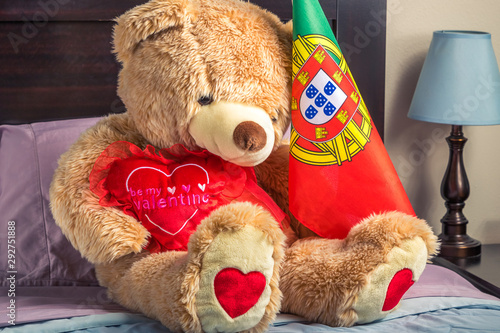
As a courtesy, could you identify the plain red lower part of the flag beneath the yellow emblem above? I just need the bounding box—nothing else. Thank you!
[289,123,415,239]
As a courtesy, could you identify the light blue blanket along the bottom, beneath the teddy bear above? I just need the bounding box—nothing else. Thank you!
[0,297,500,333]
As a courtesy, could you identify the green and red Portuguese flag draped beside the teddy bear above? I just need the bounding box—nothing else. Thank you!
[289,0,415,239]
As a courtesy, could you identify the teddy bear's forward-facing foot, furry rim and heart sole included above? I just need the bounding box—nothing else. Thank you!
[184,203,284,332]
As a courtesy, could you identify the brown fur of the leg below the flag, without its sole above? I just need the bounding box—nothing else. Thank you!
[280,212,437,326]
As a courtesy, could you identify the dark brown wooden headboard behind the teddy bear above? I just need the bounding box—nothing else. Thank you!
[0,0,386,137]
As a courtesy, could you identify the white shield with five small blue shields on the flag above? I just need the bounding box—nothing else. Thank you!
[300,69,347,125]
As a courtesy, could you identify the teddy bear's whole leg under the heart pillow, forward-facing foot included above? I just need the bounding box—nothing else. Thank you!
[96,203,284,332]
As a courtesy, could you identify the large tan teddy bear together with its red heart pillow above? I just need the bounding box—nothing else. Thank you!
[50,0,437,332]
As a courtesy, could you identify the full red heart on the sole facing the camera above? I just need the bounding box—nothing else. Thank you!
[214,268,266,318]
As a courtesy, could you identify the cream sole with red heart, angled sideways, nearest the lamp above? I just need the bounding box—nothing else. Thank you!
[352,237,427,324]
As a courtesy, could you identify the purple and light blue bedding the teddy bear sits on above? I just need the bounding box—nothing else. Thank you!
[0,264,500,333]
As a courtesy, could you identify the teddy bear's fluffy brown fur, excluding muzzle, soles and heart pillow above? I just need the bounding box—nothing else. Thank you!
[50,0,437,332]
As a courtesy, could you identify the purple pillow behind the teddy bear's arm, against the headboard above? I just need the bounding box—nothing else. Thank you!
[0,118,99,286]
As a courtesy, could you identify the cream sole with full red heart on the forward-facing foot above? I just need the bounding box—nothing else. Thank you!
[196,226,274,332]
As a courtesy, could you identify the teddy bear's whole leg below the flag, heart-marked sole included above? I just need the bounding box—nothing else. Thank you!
[280,212,437,326]
